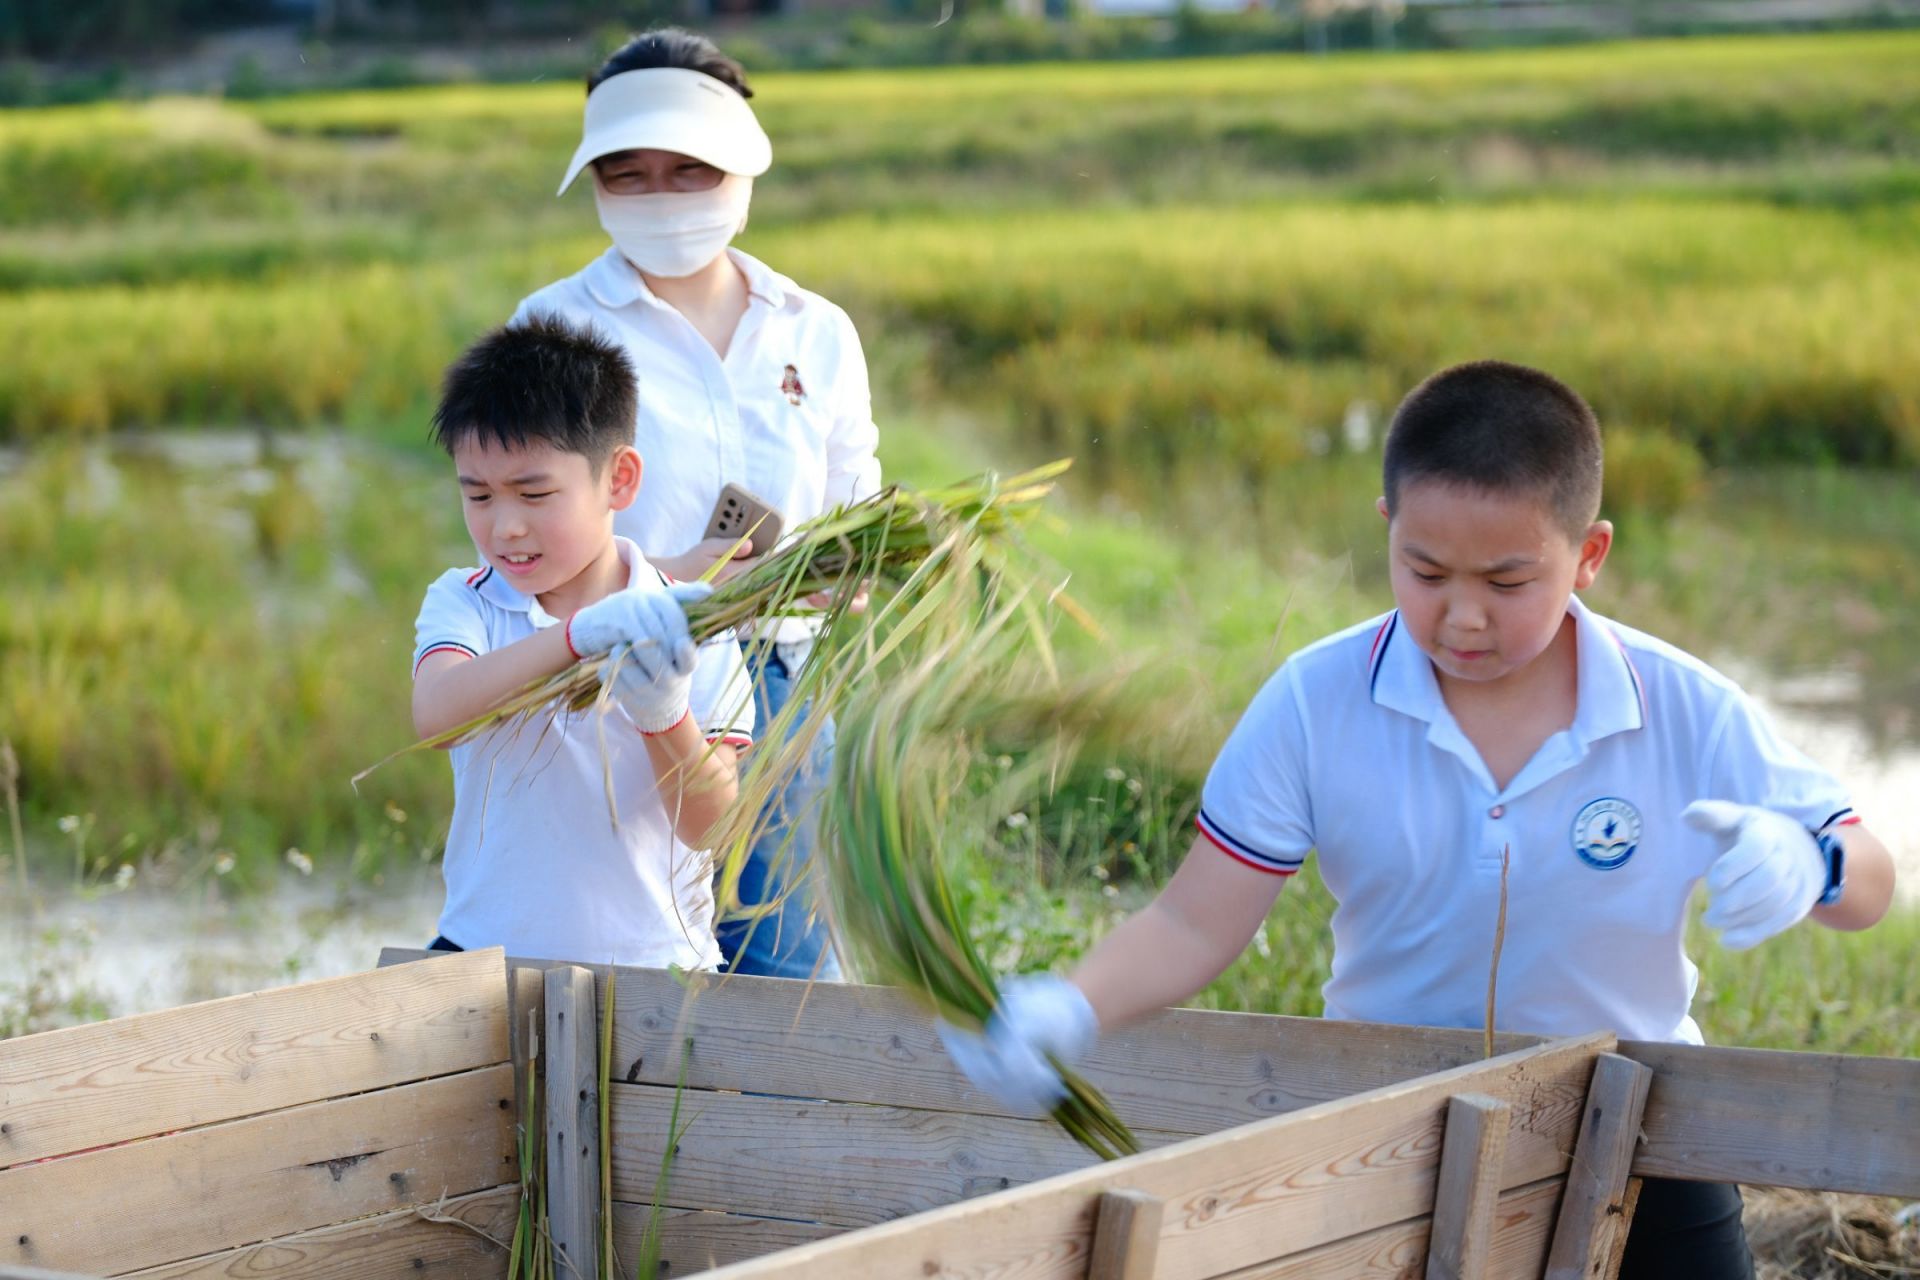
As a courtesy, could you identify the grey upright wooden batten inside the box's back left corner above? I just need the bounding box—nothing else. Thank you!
[541,965,595,1276]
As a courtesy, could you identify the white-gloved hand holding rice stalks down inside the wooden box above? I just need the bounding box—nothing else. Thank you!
[939,973,1100,1115]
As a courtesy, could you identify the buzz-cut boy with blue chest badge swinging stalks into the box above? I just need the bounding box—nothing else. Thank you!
[945,361,1893,1280]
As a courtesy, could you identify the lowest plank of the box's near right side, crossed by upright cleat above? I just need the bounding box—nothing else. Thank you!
[1219,1178,1565,1280]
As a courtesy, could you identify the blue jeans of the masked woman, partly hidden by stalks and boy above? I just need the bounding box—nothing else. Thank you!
[714,643,841,983]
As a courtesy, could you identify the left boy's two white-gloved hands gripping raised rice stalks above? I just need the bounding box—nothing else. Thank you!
[566,581,712,733]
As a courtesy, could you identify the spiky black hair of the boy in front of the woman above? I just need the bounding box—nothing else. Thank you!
[434,315,639,472]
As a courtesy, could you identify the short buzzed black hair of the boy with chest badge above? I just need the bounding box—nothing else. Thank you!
[1382,361,1601,539]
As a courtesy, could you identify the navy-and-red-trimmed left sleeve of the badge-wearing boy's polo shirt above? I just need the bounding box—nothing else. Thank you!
[1196,664,1313,875]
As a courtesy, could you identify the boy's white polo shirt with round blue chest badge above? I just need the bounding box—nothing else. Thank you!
[1198,599,1853,1042]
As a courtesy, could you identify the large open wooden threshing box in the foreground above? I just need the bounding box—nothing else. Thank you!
[0,952,1920,1280]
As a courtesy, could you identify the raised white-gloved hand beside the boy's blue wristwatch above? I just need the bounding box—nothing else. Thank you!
[1680,800,1826,952]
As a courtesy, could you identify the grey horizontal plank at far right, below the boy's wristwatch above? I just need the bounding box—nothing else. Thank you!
[1620,1040,1920,1199]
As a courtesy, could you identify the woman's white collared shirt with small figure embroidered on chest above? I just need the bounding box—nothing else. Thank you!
[513,248,879,641]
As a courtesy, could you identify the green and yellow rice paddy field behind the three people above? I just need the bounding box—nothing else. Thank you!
[0,33,1920,1054]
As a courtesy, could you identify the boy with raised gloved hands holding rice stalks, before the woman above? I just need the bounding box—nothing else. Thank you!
[413,317,753,967]
